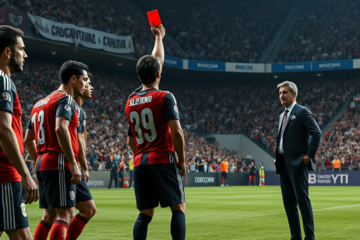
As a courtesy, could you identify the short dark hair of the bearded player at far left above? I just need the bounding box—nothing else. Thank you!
[0,25,24,52]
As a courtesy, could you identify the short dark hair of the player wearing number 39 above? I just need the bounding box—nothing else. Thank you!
[136,55,160,84]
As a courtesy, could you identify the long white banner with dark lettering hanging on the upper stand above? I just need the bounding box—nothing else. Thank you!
[28,14,134,53]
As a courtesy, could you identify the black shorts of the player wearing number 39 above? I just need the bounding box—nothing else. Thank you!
[134,163,185,210]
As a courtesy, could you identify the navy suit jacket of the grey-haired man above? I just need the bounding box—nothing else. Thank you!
[276,103,321,174]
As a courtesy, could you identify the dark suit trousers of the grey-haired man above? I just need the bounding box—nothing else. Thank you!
[280,164,315,240]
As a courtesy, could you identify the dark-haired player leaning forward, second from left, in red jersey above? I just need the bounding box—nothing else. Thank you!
[25,61,88,240]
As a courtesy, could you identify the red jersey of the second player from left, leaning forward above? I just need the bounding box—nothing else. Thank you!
[27,91,79,171]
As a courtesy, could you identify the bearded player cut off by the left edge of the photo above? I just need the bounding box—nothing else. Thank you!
[0,25,39,239]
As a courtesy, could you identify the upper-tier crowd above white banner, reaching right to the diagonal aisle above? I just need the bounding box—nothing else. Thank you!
[12,0,295,62]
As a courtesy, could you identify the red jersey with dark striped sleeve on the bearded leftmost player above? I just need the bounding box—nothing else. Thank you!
[0,70,24,183]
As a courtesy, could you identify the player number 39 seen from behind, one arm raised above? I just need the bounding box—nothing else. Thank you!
[126,25,186,240]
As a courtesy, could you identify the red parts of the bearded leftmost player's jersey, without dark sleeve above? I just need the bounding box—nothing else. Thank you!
[0,94,24,183]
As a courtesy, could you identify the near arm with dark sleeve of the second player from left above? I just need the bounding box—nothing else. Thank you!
[55,96,81,184]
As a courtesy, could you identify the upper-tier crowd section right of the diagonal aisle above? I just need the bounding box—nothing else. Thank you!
[275,0,360,62]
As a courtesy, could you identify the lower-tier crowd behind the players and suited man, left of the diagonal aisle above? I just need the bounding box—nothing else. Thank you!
[14,61,360,171]
